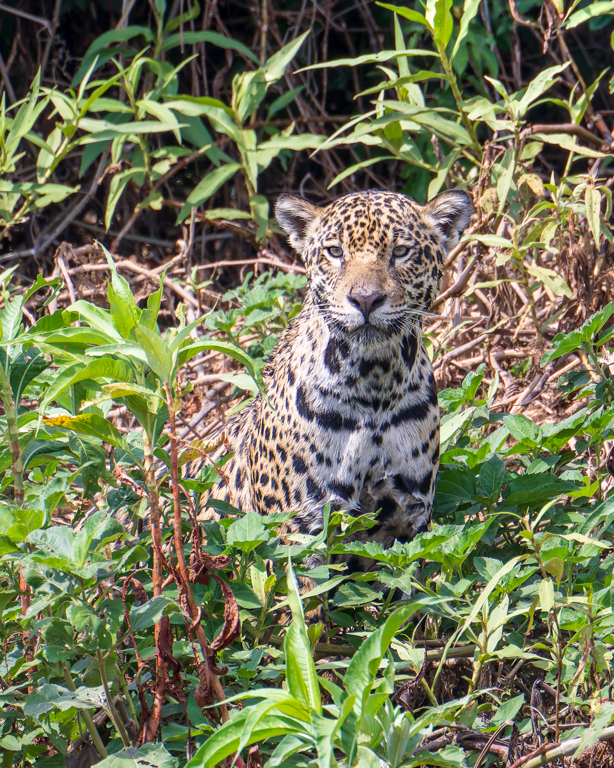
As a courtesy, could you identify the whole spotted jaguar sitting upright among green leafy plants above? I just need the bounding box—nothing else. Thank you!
[195,190,471,567]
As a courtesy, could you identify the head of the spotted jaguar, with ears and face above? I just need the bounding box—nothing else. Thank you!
[276,190,472,338]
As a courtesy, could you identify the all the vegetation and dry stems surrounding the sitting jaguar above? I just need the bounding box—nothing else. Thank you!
[0,0,614,768]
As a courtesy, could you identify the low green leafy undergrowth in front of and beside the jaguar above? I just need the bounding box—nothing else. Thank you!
[0,257,614,768]
